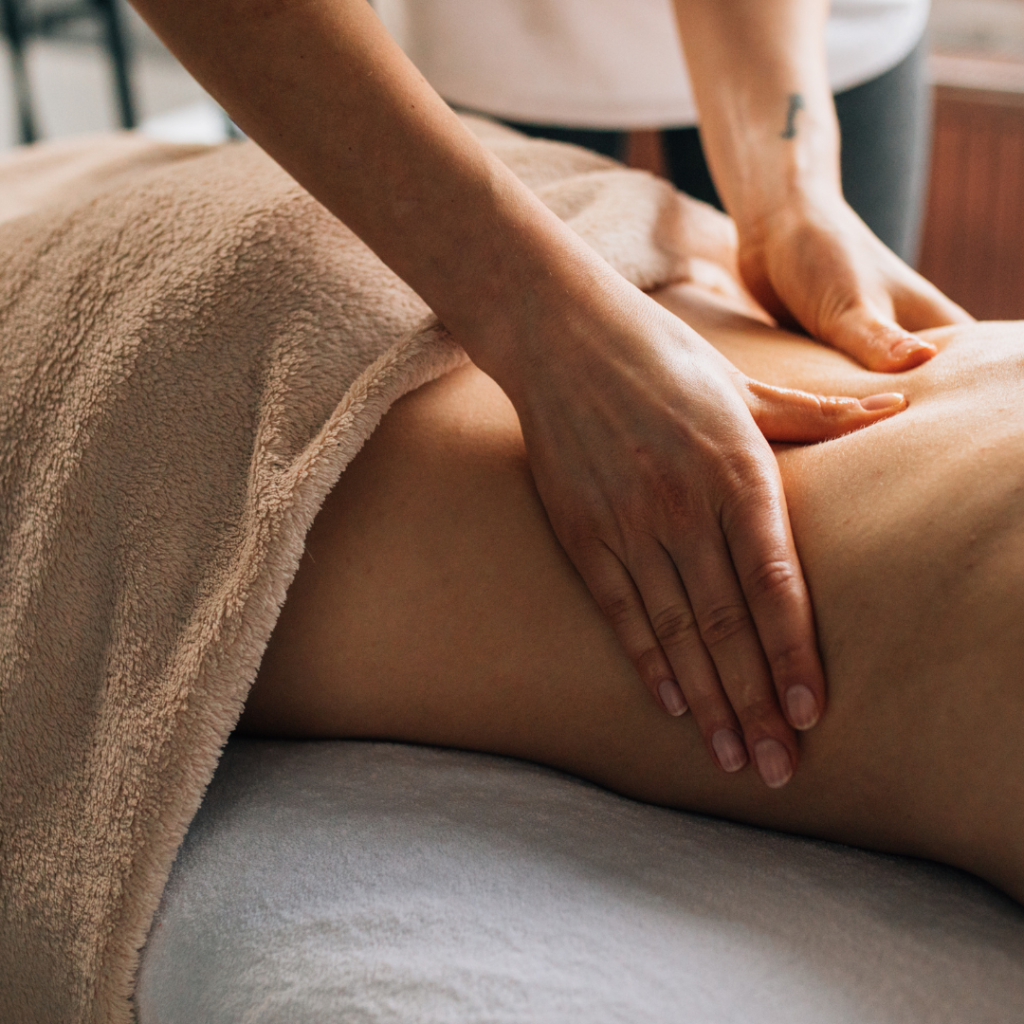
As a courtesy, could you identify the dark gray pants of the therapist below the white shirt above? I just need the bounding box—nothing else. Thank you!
[499,40,931,262]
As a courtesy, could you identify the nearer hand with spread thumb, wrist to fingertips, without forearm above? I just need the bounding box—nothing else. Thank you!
[485,260,905,786]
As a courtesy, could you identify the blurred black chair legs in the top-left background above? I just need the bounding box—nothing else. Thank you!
[0,0,136,142]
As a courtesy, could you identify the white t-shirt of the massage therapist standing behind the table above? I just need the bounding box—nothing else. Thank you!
[373,0,930,128]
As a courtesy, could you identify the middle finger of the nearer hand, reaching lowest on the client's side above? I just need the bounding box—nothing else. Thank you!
[670,523,798,788]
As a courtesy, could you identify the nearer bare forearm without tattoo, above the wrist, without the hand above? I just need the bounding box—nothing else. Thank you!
[124,0,598,384]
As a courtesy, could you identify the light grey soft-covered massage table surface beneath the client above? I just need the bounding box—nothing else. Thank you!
[136,740,1024,1024]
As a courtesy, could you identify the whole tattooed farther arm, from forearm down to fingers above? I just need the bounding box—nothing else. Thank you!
[675,0,971,371]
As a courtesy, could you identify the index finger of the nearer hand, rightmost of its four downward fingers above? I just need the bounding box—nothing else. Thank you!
[723,461,825,745]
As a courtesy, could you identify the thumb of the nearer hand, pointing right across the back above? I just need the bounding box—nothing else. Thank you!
[745,380,906,443]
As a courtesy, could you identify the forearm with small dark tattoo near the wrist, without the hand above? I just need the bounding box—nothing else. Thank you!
[676,0,841,232]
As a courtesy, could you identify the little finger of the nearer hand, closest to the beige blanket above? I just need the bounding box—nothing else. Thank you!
[571,544,687,718]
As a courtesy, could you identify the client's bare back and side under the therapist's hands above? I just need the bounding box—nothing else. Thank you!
[241,285,1024,901]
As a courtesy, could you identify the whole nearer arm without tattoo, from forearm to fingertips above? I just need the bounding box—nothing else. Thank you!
[125,0,901,785]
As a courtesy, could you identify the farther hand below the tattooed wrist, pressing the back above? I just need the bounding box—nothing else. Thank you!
[739,189,972,372]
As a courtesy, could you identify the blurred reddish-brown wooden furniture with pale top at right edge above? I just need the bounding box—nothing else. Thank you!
[919,56,1024,319]
